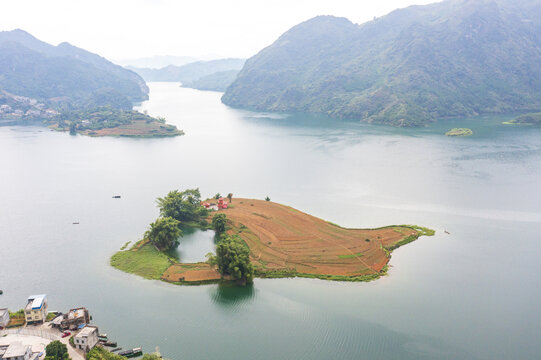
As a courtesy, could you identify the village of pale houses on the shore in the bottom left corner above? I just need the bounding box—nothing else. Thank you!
[0,294,143,360]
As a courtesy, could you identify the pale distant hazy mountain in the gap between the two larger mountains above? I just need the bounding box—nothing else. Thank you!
[128,59,245,83]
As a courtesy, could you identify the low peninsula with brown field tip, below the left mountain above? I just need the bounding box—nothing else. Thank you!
[46,107,184,138]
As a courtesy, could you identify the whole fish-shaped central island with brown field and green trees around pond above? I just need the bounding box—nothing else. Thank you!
[111,189,434,284]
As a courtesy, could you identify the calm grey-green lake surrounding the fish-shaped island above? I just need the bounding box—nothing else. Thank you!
[0,83,541,360]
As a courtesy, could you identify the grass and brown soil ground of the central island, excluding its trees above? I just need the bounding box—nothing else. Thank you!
[111,190,434,284]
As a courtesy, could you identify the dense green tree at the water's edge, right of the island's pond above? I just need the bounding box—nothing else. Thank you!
[216,236,254,284]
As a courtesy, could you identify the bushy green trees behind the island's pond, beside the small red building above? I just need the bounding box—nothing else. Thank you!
[156,189,208,221]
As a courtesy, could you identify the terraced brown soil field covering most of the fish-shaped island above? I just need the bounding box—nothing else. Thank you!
[155,198,433,283]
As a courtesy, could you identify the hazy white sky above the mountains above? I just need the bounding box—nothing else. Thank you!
[0,0,435,59]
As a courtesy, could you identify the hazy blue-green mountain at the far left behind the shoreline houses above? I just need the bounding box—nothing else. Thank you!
[0,30,148,108]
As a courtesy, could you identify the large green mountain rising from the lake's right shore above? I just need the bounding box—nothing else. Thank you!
[222,0,541,126]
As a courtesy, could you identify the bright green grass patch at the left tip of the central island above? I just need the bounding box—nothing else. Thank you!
[111,244,174,280]
